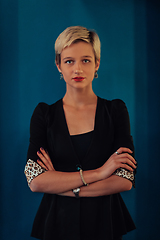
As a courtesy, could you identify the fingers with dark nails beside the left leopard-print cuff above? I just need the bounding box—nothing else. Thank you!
[37,148,55,171]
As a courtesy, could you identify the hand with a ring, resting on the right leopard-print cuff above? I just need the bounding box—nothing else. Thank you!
[99,147,136,179]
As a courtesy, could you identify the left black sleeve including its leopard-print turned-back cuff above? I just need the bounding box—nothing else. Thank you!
[24,103,48,185]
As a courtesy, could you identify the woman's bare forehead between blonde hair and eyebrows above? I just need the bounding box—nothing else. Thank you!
[61,41,94,59]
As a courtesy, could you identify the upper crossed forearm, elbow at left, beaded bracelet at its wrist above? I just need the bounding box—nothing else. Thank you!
[30,170,101,194]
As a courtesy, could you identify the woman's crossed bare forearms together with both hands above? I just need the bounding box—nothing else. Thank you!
[30,148,136,197]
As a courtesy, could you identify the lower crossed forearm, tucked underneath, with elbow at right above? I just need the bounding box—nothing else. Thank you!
[61,175,132,197]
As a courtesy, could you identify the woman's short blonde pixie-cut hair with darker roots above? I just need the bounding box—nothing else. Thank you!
[55,26,101,65]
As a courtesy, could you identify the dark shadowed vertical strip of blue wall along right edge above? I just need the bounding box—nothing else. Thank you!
[135,1,160,240]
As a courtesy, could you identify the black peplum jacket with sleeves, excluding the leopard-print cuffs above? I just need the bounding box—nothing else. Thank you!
[27,97,135,240]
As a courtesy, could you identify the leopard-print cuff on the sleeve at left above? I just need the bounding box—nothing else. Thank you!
[24,159,46,185]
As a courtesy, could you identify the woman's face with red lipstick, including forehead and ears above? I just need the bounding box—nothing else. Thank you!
[57,42,99,88]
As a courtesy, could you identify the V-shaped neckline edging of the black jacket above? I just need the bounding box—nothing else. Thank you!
[61,96,99,168]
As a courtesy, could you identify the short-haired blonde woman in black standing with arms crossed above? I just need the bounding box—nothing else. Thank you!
[25,26,136,240]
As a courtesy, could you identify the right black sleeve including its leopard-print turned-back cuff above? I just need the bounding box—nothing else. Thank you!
[112,99,136,187]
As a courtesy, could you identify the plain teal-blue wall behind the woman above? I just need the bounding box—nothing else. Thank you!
[0,0,160,240]
